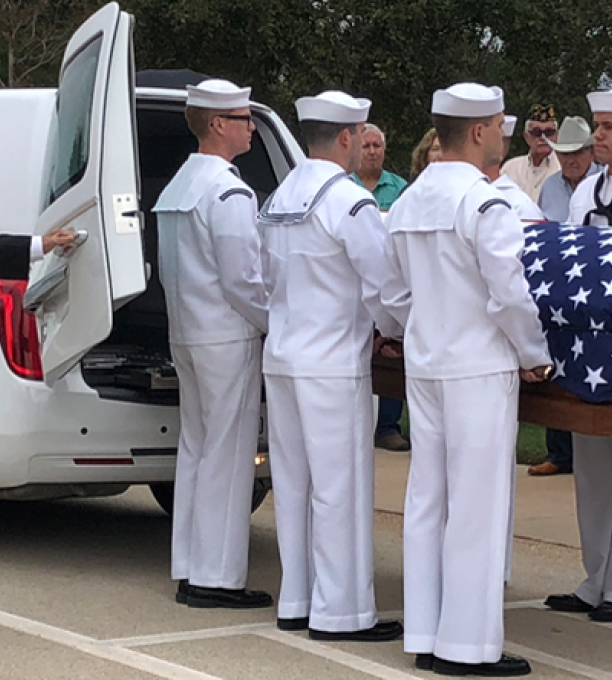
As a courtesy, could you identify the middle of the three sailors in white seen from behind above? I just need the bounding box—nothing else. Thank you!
[259,91,407,642]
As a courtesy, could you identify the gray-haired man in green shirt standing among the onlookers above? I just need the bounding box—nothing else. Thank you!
[352,123,410,451]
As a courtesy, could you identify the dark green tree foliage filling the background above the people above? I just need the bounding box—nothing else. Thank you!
[7,0,612,175]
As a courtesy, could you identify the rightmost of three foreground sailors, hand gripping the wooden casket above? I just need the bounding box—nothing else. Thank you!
[383,83,550,677]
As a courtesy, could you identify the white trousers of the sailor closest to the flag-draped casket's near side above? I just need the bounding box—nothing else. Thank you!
[404,372,519,663]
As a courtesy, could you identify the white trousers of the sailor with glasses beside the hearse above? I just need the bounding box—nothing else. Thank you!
[171,338,261,588]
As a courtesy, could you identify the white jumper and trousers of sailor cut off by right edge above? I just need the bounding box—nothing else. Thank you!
[568,167,612,607]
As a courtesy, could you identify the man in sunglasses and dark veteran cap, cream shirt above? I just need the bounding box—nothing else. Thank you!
[501,104,561,203]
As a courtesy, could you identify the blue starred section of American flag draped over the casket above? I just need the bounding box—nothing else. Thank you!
[523,222,612,404]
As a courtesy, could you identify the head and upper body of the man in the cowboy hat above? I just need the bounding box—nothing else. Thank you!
[539,116,600,222]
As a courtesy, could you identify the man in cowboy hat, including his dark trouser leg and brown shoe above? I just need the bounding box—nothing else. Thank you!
[527,116,600,477]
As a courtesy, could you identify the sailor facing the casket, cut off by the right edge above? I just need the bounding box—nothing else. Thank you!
[545,91,612,623]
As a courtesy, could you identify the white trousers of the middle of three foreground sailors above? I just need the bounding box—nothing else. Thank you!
[266,375,377,631]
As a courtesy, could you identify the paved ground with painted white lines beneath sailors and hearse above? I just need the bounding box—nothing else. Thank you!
[0,455,612,680]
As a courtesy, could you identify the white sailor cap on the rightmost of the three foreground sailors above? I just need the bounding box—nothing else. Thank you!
[431,83,504,118]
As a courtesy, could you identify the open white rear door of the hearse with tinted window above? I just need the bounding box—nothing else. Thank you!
[25,2,146,385]
